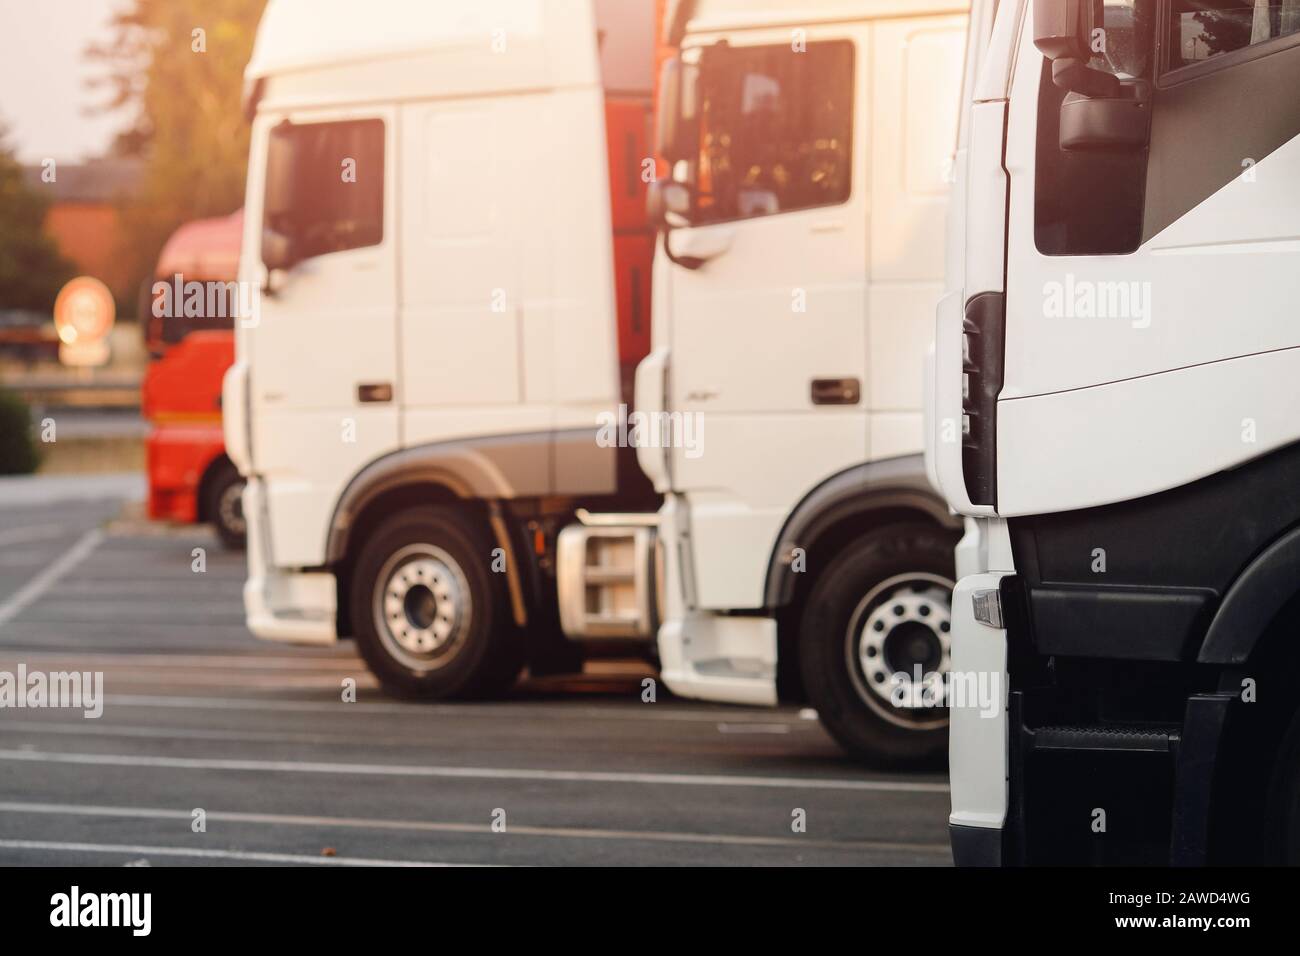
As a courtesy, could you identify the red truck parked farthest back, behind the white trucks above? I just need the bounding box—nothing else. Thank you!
[140,211,246,548]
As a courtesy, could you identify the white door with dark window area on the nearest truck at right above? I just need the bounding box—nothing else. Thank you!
[997,0,1300,515]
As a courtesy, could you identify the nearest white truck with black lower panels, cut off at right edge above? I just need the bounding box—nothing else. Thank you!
[927,0,1300,865]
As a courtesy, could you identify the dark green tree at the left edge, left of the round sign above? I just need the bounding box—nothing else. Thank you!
[0,126,74,312]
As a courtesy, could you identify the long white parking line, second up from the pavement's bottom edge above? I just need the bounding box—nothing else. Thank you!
[0,801,950,853]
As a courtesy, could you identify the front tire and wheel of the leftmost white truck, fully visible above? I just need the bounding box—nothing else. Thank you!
[351,507,521,700]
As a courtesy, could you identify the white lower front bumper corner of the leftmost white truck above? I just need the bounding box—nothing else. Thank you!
[243,479,338,645]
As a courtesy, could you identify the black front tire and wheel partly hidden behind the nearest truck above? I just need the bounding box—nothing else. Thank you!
[798,524,957,767]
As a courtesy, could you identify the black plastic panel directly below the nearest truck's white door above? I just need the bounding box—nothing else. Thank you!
[1008,444,1300,663]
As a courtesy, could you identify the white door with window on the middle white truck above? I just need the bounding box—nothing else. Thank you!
[667,31,871,607]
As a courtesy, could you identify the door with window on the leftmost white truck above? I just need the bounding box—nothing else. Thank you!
[243,108,399,567]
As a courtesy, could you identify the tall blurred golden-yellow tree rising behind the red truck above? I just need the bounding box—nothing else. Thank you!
[87,0,267,317]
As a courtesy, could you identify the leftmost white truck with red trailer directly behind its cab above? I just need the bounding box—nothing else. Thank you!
[225,0,659,697]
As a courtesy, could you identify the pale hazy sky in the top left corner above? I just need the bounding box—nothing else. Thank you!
[0,0,126,163]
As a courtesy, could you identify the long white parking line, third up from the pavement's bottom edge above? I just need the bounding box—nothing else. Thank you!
[0,750,948,793]
